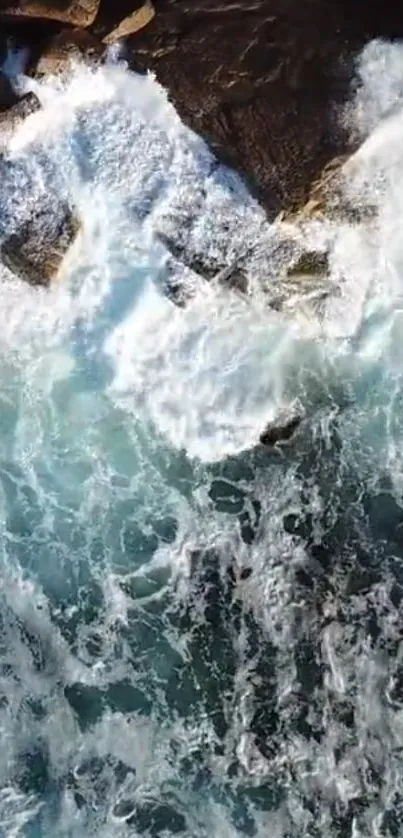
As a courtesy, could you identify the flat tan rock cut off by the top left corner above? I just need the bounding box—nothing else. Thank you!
[0,0,100,27]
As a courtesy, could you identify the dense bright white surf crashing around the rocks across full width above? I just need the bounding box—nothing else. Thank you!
[0,43,403,466]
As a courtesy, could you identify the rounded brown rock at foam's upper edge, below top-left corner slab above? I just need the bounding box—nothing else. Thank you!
[30,28,104,76]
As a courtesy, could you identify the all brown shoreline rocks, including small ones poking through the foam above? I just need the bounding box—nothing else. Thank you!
[0,0,403,445]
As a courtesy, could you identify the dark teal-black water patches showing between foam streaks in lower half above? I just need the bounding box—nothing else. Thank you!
[1,404,403,838]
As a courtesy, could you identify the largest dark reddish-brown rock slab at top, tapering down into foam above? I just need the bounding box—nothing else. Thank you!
[127,0,403,216]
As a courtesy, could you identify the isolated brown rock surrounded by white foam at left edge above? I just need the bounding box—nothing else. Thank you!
[0,203,79,285]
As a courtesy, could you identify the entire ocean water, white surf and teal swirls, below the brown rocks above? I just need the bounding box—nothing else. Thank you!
[0,37,403,838]
